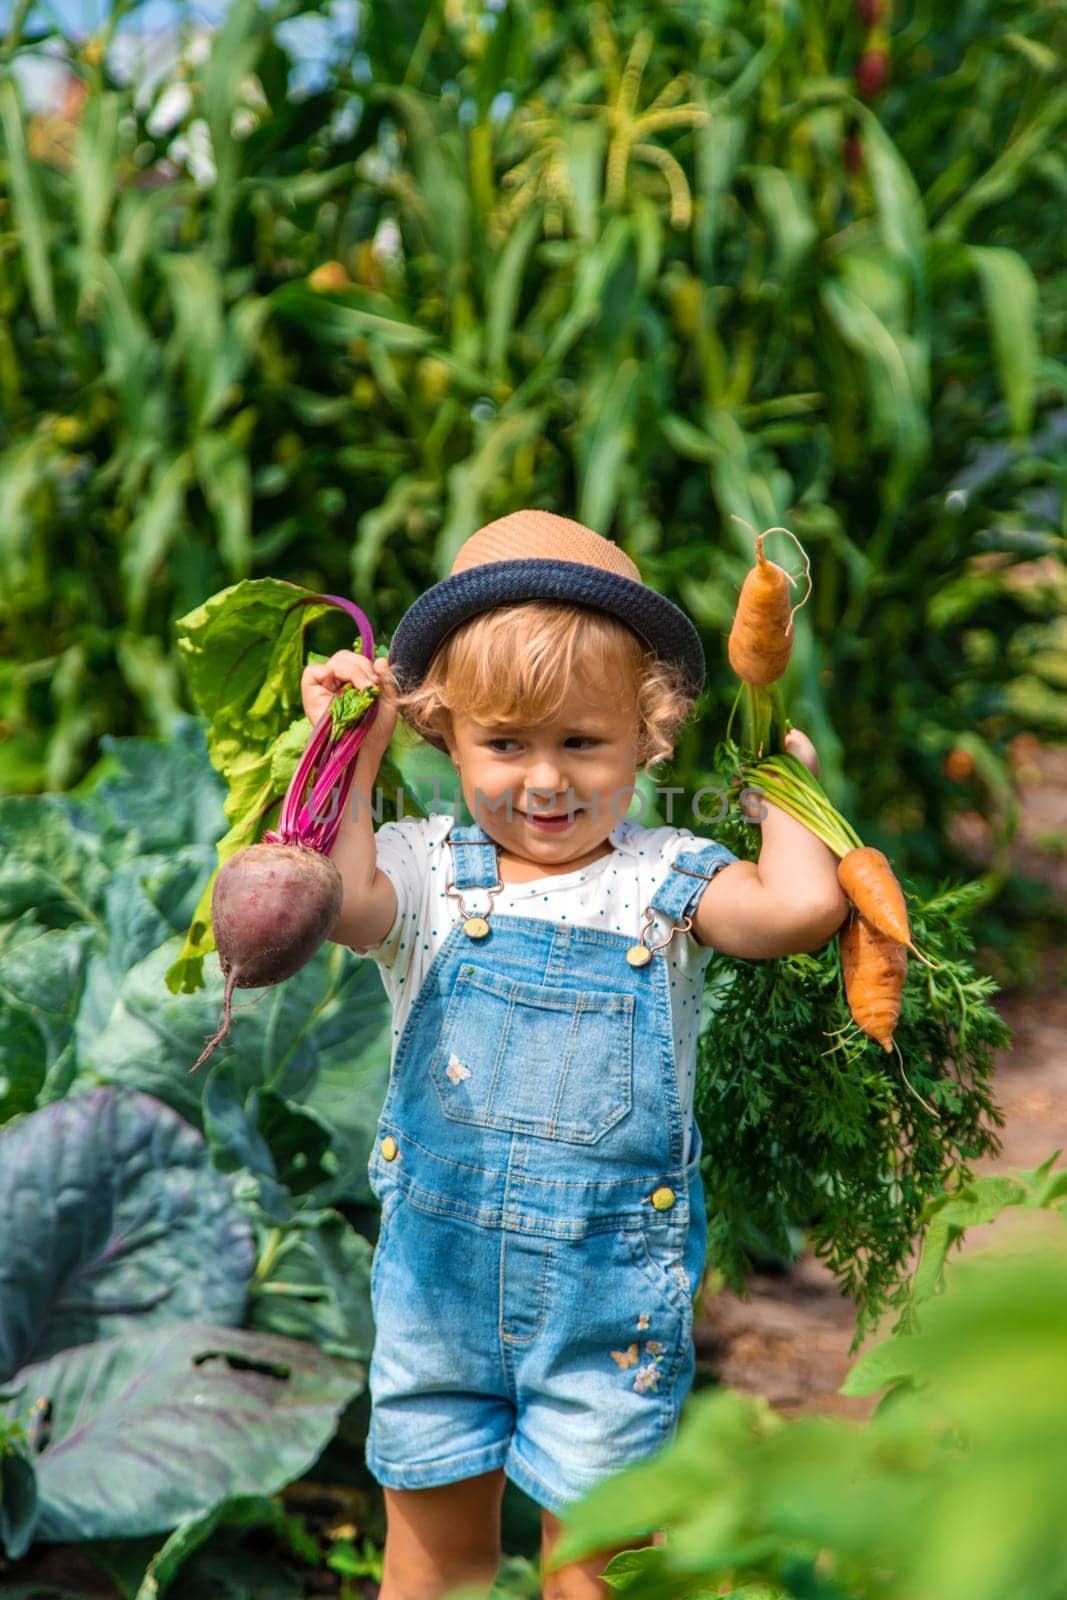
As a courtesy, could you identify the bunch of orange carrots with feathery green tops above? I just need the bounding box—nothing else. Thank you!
[696,539,1009,1342]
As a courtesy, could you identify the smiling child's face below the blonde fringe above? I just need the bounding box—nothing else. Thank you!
[450,685,638,867]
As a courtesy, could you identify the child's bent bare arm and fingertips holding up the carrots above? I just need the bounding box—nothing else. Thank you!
[693,730,848,960]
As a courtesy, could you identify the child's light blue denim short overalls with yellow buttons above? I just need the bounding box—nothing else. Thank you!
[366,824,736,1515]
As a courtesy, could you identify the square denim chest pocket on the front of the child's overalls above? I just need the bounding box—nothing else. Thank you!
[430,962,633,1144]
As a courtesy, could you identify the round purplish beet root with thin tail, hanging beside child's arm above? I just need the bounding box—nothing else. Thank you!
[189,845,342,1072]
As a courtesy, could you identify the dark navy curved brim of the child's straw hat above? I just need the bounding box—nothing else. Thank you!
[389,558,704,696]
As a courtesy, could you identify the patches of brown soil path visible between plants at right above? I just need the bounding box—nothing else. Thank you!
[694,739,1067,1418]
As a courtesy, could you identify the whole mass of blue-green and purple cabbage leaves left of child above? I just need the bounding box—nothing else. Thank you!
[0,718,389,1566]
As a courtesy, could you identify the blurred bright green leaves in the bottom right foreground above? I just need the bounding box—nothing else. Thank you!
[558,1163,1067,1600]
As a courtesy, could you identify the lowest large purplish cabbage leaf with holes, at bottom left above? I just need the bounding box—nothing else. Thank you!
[2,1320,366,1557]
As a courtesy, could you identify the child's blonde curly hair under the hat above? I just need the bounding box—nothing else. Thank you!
[397,600,696,770]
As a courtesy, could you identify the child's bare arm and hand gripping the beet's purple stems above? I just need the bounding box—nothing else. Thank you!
[301,650,397,950]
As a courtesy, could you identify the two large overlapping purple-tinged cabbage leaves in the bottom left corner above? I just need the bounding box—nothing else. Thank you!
[0,1086,370,1558]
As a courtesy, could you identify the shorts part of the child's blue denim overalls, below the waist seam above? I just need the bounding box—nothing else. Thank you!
[366,1139,707,1517]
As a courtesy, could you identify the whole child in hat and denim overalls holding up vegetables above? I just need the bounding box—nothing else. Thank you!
[302,510,846,1600]
